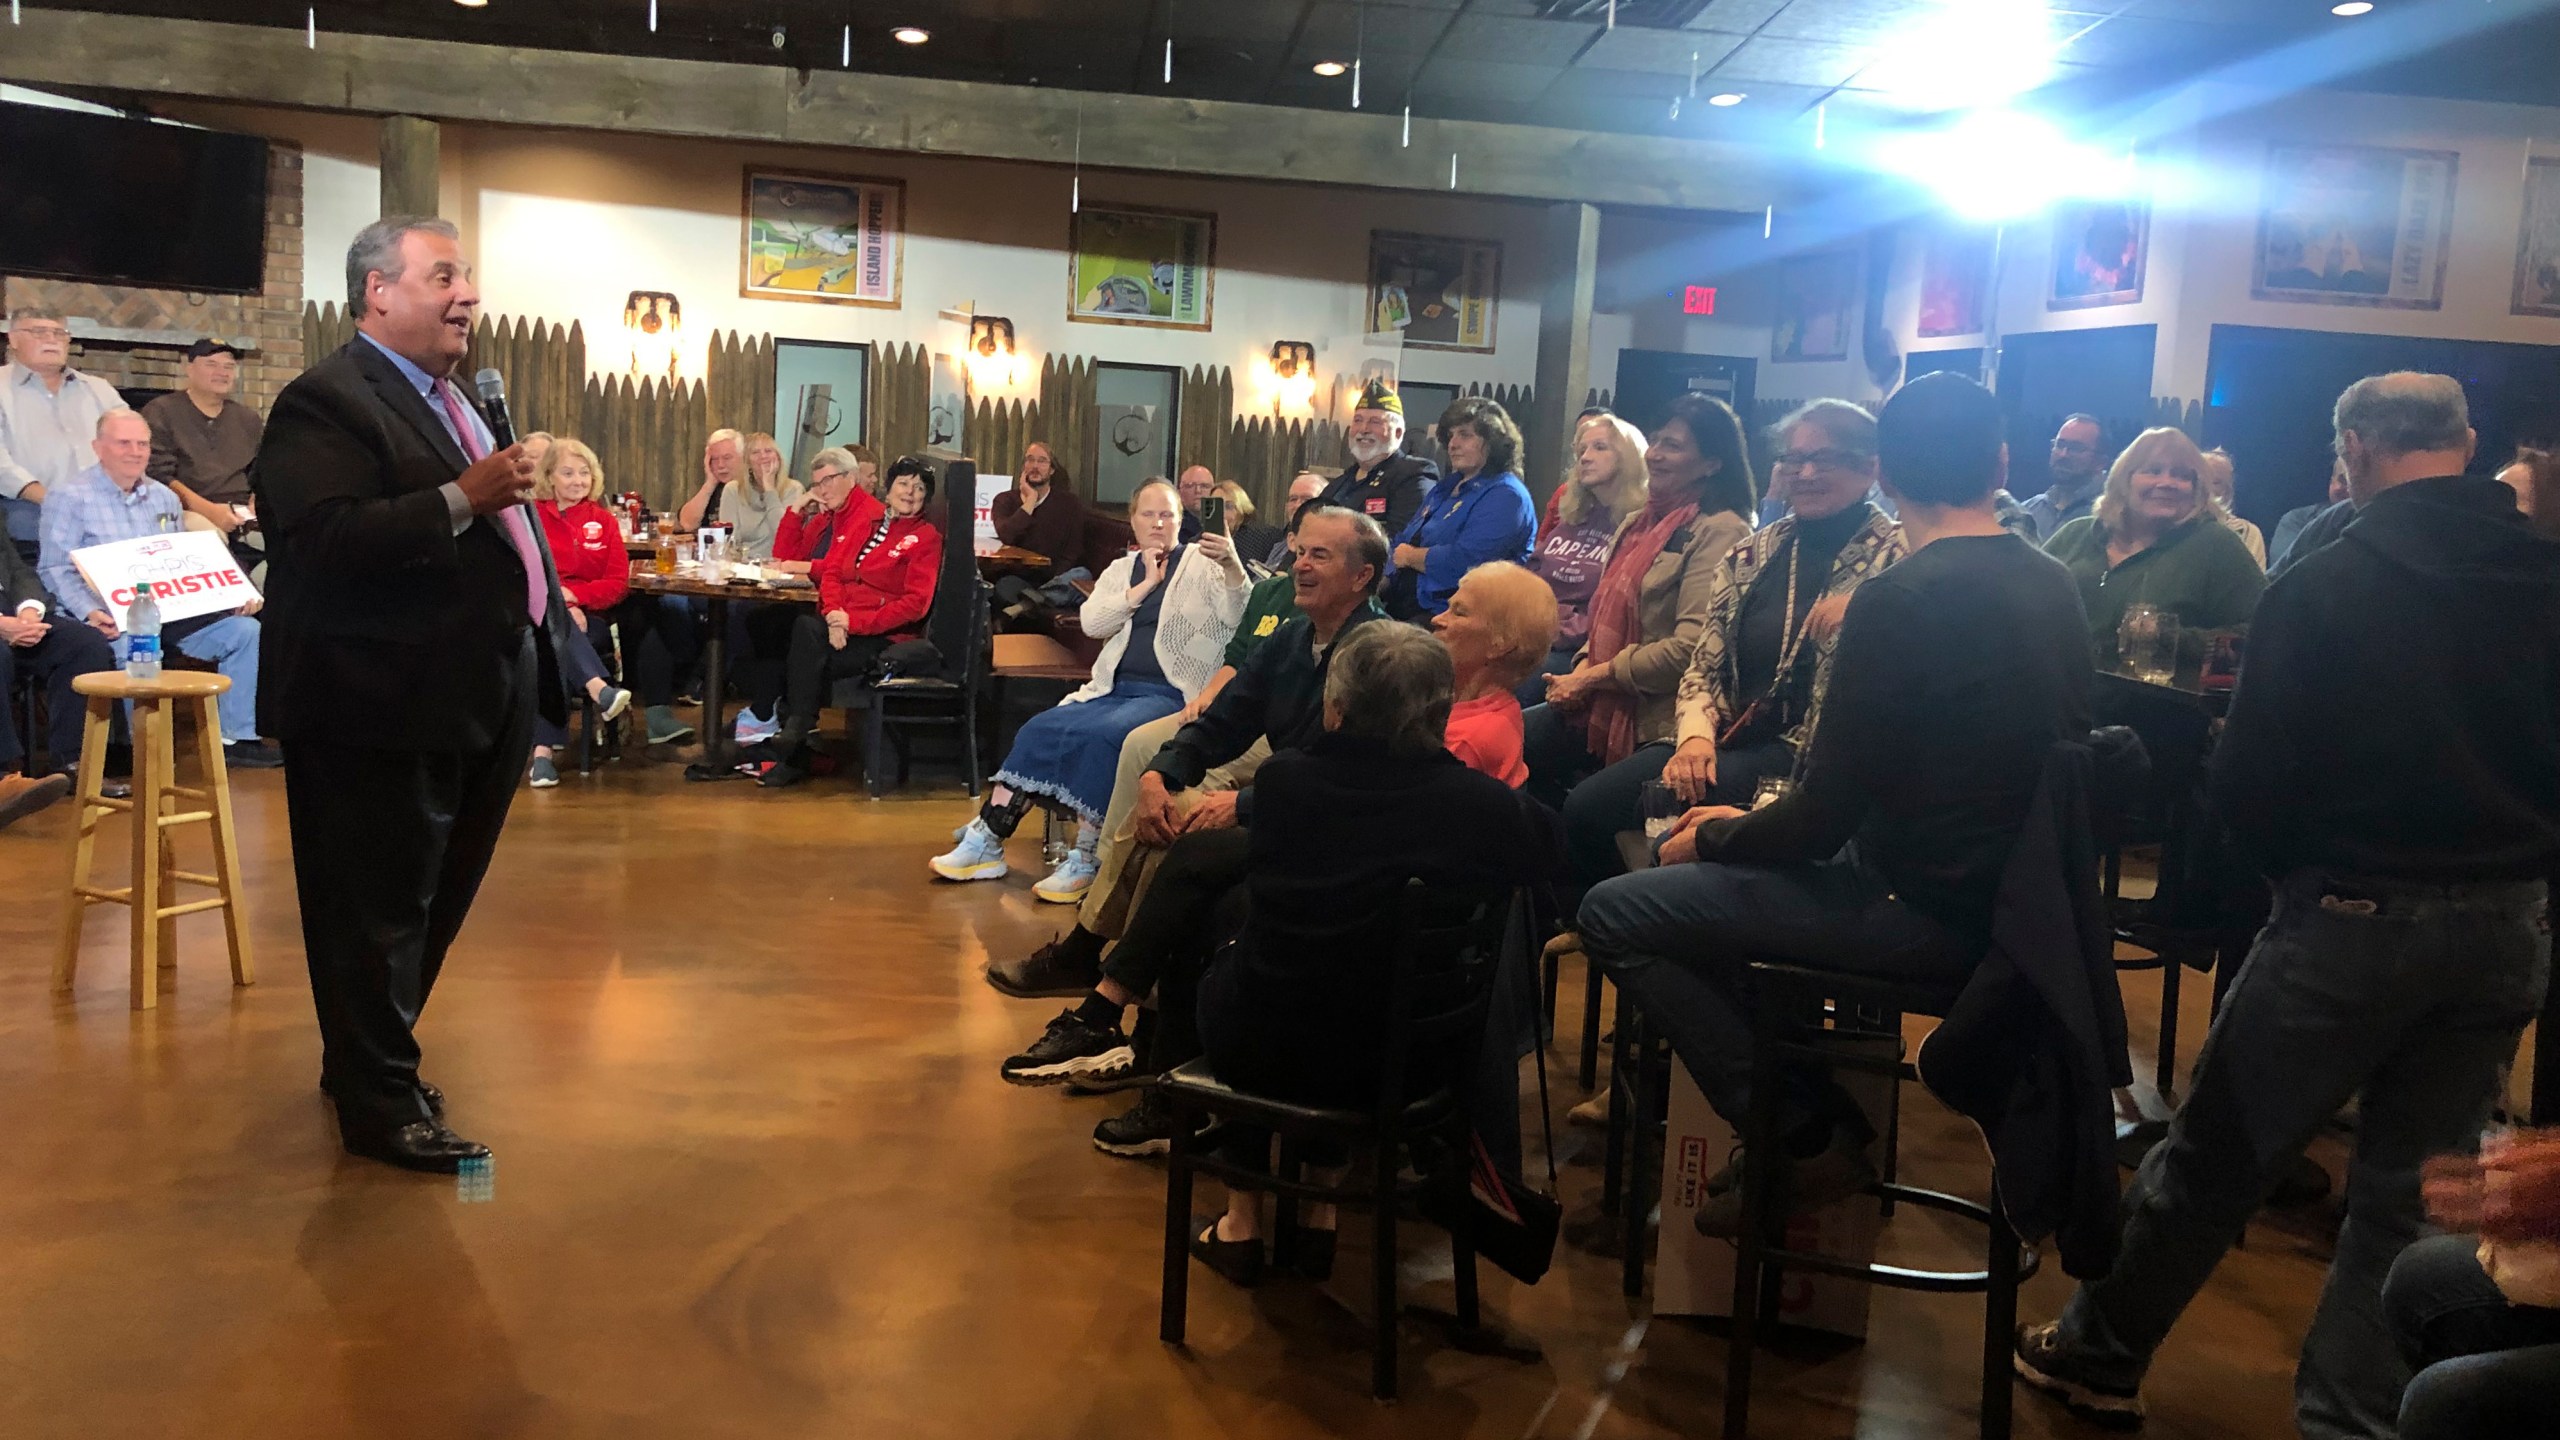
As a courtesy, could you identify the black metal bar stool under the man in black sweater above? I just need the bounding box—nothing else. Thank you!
[1725,961,2038,1440]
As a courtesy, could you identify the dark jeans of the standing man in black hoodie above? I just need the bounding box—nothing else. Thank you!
[2061,869,2550,1440]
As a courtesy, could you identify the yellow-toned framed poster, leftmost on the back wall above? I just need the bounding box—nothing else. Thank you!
[737,169,906,310]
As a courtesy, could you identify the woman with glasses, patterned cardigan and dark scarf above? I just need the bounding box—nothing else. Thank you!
[1648,400,1914,825]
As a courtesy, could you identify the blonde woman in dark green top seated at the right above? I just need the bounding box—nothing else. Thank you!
[2045,425,2266,666]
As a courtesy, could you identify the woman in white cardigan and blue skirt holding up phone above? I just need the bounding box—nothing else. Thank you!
[932,482,1249,899]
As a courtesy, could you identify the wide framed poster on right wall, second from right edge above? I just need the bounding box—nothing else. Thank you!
[2250,146,2460,310]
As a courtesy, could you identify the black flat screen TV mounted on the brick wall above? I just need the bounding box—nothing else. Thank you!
[0,105,266,295]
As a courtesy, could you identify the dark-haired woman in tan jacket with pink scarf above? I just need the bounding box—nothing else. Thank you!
[1526,395,1761,887]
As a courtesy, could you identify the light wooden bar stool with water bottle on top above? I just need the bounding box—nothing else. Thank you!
[54,671,256,1010]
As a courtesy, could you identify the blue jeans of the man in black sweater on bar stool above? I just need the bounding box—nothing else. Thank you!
[1582,848,1981,1133]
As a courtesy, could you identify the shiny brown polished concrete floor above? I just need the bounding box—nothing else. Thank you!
[0,727,2508,1440]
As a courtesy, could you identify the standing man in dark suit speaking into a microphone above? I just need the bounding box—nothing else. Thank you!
[256,218,568,1174]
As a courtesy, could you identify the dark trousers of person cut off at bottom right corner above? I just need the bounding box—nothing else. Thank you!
[2383,1235,2560,1440]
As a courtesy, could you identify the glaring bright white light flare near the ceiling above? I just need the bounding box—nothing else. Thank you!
[1876,110,2143,220]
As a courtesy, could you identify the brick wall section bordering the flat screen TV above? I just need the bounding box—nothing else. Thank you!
[0,141,305,413]
